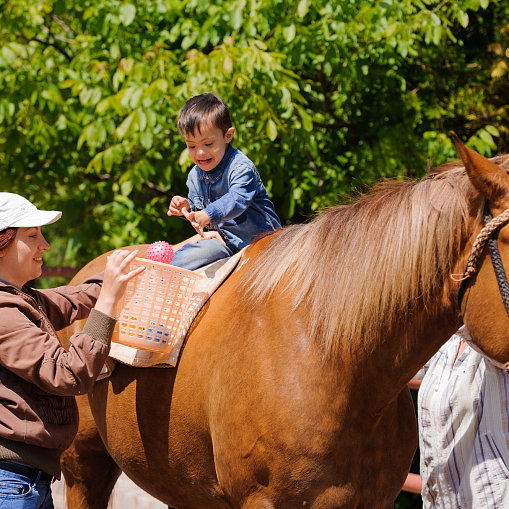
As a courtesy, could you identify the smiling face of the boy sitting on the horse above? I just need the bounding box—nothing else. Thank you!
[184,124,235,171]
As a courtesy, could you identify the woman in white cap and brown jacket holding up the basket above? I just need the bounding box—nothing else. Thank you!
[0,193,141,509]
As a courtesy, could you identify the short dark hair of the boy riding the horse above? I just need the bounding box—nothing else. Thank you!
[177,93,232,136]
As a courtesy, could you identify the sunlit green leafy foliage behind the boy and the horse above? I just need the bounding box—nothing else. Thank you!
[0,0,509,265]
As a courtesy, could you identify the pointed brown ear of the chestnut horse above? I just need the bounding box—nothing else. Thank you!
[451,131,509,209]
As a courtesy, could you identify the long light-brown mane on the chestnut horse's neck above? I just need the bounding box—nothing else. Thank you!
[241,156,509,352]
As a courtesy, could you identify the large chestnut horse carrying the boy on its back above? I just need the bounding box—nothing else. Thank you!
[58,135,509,509]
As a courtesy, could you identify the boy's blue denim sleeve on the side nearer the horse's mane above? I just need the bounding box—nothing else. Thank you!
[205,164,257,226]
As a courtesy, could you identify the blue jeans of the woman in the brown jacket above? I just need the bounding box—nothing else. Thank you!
[0,469,54,509]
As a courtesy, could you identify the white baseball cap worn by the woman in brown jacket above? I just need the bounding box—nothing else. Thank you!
[0,193,62,231]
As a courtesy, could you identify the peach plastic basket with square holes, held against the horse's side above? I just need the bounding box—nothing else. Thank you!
[112,258,203,353]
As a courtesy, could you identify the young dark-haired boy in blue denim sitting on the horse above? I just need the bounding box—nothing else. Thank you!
[168,94,281,270]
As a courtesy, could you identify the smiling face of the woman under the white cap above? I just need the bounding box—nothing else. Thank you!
[0,226,49,286]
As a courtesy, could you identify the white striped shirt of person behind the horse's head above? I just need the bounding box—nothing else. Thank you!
[414,327,509,509]
